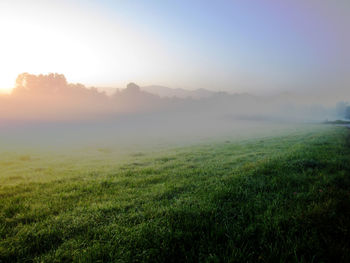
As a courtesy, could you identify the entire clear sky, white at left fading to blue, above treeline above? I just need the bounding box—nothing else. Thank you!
[0,0,350,93]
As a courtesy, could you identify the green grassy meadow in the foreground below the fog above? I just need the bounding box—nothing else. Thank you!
[0,125,350,262]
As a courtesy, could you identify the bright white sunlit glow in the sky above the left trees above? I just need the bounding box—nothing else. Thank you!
[0,0,165,93]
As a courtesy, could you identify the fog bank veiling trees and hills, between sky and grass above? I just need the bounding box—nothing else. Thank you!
[0,73,347,150]
